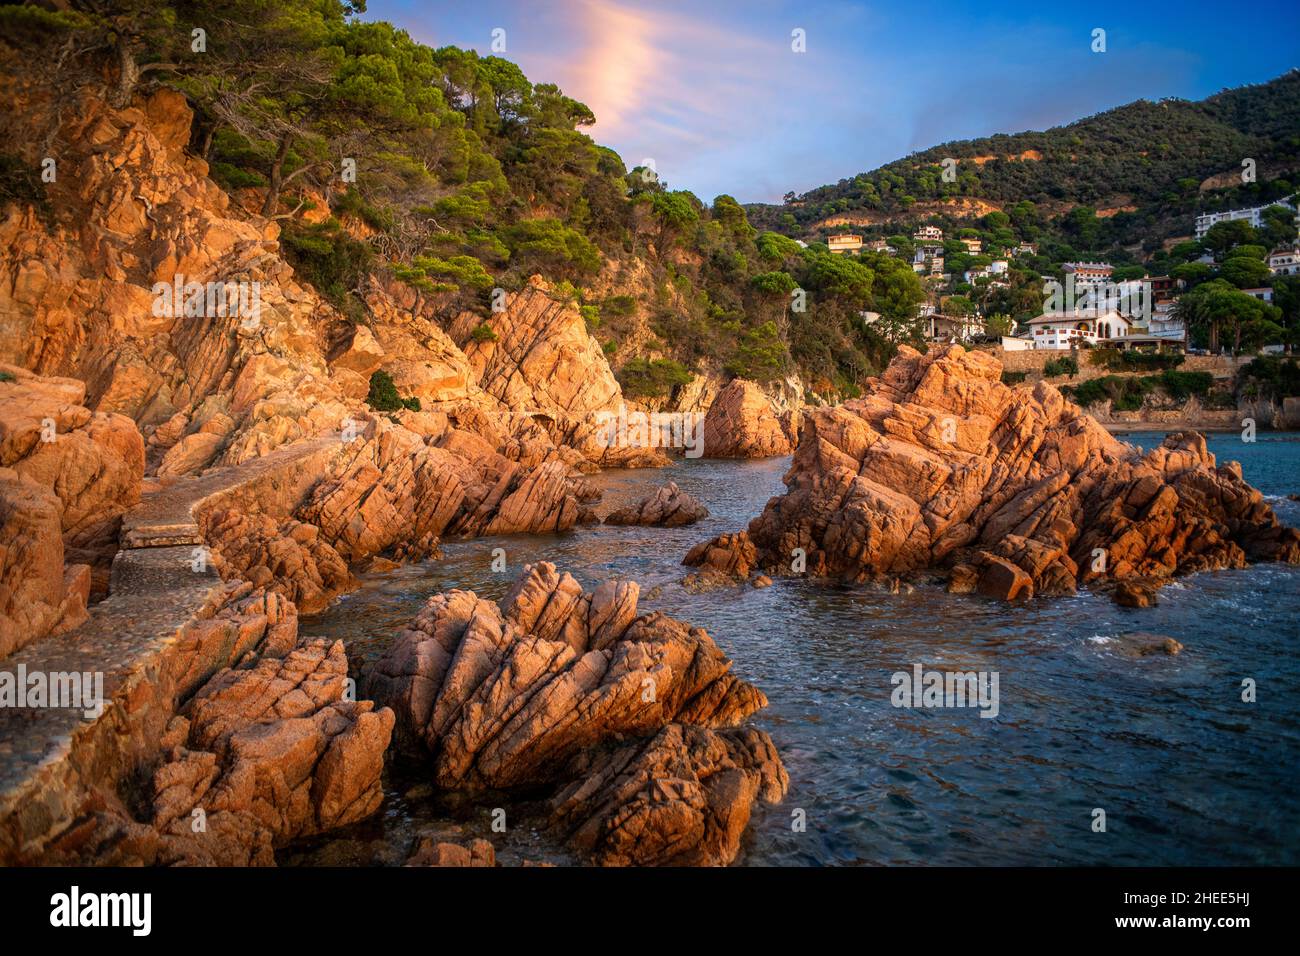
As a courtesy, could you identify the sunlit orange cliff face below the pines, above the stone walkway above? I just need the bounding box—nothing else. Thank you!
[0,90,670,476]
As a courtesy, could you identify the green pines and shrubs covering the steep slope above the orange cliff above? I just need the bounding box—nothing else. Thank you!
[0,0,922,394]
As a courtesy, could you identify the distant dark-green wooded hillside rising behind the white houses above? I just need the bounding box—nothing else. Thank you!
[746,70,1300,252]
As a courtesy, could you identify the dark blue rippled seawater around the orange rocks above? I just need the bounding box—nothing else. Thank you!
[295,433,1300,865]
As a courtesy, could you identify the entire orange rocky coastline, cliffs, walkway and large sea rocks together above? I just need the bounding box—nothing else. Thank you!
[0,90,1300,865]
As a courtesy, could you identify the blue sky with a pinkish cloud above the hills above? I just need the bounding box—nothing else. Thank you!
[365,0,1300,203]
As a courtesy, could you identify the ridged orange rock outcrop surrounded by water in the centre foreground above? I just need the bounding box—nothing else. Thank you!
[368,562,787,862]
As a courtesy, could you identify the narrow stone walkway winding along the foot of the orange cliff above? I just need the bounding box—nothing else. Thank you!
[0,436,346,860]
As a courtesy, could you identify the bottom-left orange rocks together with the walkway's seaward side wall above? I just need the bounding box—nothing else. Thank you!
[0,580,394,866]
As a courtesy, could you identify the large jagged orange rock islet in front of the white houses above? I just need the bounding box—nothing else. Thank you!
[688,346,1300,600]
